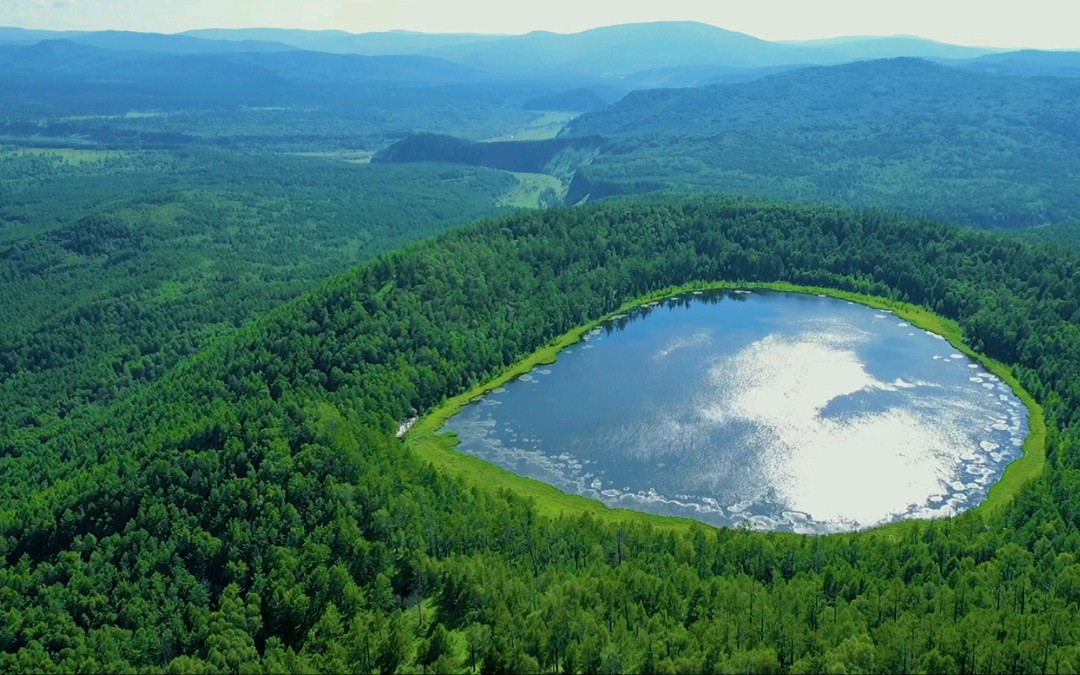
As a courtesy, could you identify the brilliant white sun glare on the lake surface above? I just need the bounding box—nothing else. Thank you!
[702,332,963,525]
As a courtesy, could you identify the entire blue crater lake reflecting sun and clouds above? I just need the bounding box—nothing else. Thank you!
[444,291,1027,534]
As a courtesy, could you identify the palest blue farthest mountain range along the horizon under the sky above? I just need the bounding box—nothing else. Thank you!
[0,22,1076,87]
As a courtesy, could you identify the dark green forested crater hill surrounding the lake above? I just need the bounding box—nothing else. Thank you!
[0,195,1080,673]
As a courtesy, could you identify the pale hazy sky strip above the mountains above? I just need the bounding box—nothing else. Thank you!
[0,0,1080,49]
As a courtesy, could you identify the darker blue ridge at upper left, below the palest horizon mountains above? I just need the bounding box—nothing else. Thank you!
[0,33,491,111]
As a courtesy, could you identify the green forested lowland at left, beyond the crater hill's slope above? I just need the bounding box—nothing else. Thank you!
[0,149,518,440]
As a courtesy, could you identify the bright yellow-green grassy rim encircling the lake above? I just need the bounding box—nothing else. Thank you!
[405,282,1047,536]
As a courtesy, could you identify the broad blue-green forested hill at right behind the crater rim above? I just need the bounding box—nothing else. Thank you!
[565,59,1080,228]
